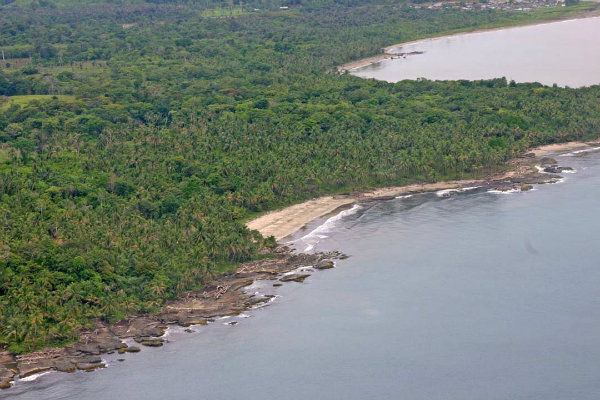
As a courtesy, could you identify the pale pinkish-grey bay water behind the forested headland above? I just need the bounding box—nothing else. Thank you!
[352,17,600,87]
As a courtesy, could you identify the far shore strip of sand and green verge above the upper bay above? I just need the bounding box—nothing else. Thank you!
[337,1,600,73]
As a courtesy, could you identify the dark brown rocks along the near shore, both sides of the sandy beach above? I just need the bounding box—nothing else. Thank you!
[0,149,584,389]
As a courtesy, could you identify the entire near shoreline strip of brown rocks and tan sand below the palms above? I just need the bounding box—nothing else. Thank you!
[0,139,600,389]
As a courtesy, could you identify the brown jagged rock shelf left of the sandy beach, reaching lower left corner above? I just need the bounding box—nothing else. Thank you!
[0,246,345,389]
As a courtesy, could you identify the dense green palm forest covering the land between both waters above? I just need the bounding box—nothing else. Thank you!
[0,0,600,352]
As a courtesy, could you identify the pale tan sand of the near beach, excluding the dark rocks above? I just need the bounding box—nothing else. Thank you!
[246,141,600,240]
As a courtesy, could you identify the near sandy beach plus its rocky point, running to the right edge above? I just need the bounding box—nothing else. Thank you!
[246,141,600,241]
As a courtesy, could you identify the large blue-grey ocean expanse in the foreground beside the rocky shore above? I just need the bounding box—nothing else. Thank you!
[5,152,600,400]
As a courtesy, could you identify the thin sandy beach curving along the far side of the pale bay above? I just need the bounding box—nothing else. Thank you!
[337,8,600,73]
